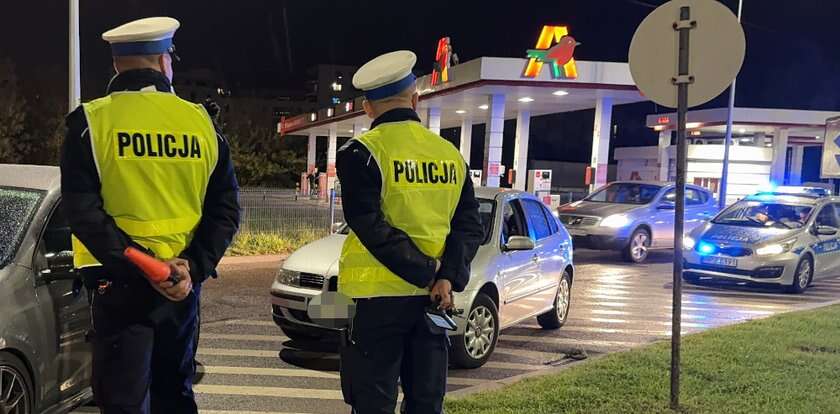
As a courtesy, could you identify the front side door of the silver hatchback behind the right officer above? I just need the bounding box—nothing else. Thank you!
[499,200,540,326]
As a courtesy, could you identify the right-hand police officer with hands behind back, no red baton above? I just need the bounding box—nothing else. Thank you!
[336,51,484,414]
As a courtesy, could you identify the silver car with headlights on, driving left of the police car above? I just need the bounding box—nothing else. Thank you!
[558,181,718,263]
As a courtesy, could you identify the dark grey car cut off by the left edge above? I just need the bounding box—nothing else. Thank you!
[0,164,92,414]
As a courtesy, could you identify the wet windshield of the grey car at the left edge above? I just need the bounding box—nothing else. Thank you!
[0,187,44,268]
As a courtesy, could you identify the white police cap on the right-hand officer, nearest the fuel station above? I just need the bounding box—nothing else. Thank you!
[353,50,417,101]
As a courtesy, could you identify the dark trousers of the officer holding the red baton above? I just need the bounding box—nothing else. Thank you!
[85,274,200,414]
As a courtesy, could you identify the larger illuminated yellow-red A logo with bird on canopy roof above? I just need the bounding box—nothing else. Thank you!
[522,26,580,79]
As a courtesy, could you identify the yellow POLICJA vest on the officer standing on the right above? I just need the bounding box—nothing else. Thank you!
[338,121,466,298]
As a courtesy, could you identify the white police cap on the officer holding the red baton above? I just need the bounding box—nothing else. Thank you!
[102,17,181,56]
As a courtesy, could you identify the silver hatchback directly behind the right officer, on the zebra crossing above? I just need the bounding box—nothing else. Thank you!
[271,188,574,368]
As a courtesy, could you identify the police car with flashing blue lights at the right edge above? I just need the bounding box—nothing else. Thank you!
[683,194,840,293]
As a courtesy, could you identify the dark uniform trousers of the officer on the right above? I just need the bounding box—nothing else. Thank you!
[341,296,449,414]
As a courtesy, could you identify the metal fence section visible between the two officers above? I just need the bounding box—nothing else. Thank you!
[239,187,344,236]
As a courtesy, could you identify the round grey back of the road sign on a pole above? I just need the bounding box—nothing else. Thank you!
[629,0,746,108]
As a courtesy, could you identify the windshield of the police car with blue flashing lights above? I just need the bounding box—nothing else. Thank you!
[712,201,813,229]
